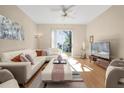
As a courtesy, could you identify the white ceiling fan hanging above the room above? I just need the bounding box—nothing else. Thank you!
[52,5,75,18]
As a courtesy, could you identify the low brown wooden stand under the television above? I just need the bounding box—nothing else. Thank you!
[89,55,111,69]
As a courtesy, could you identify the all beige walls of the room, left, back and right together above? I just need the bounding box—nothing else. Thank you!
[0,6,124,57]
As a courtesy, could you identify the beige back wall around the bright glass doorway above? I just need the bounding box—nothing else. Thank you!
[38,24,86,56]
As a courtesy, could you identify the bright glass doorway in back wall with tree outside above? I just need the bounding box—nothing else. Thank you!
[52,30,72,56]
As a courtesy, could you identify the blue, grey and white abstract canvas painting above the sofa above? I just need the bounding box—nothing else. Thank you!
[0,15,24,40]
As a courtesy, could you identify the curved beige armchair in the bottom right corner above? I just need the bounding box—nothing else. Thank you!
[105,59,124,88]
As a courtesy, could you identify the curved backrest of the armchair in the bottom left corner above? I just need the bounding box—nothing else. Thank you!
[0,69,14,83]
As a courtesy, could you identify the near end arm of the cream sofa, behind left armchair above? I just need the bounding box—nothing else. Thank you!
[0,62,31,84]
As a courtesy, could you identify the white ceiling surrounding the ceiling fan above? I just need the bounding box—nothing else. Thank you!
[18,5,111,24]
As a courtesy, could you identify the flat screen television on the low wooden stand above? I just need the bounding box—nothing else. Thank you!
[91,42,110,59]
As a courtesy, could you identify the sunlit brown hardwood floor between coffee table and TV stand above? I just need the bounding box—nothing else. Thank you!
[77,59,106,88]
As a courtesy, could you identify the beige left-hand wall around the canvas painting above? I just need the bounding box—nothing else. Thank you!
[0,5,36,52]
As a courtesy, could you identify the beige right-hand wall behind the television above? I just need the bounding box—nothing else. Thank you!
[87,6,124,58]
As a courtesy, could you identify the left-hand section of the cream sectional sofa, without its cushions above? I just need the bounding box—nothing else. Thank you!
[0,49,46,84]
